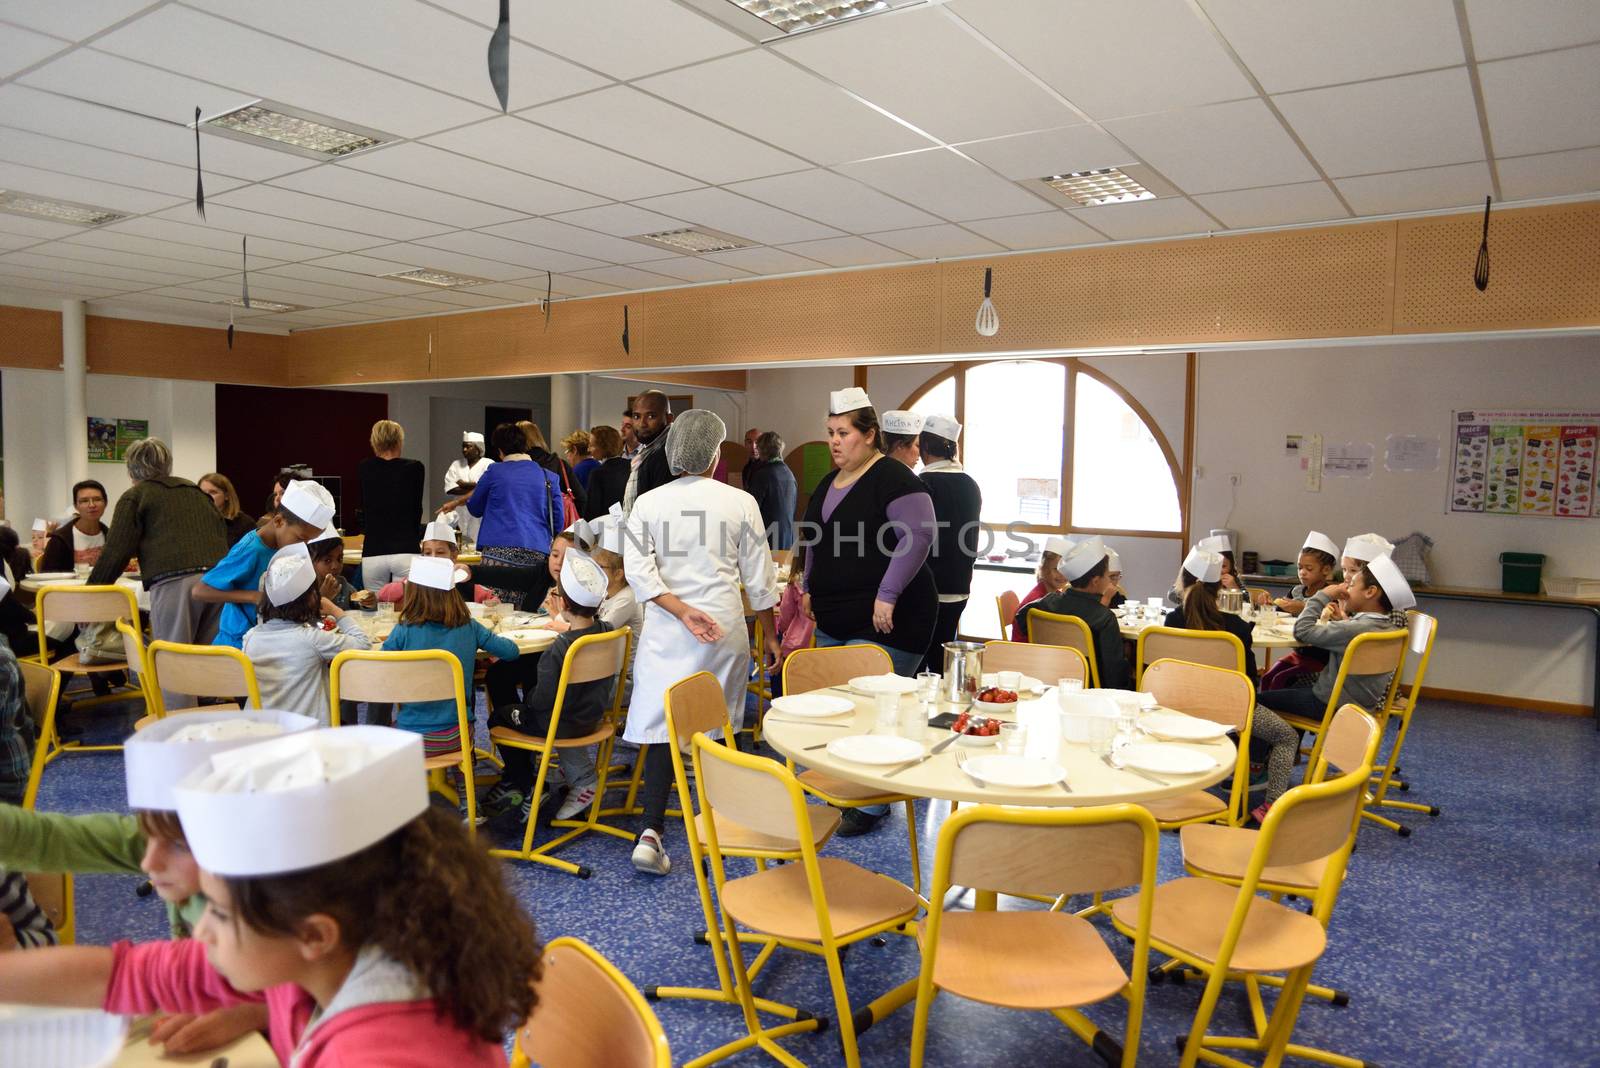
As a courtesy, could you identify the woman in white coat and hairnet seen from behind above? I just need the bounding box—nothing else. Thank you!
[622,409,778,875]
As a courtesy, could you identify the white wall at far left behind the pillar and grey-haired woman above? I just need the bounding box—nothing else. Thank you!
[0,368,216,531]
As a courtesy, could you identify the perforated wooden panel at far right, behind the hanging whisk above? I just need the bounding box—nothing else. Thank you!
[1395,203,1600,334]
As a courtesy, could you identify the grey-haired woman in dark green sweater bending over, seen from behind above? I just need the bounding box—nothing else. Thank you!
[90,438,227,708]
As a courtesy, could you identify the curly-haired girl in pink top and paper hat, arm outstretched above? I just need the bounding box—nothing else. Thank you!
[0,727,541,1068]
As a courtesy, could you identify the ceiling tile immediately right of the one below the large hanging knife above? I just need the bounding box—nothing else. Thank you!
[520,85,806,185]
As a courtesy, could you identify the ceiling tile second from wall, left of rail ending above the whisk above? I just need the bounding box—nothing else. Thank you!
[1274,67,1483,177]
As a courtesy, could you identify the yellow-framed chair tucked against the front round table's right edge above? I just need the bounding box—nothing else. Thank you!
[1141,661,1256,831]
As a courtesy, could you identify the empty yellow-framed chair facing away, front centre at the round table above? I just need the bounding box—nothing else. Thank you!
[910,804,1160,1068]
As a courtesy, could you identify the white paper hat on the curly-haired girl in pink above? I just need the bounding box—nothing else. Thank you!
[174,725,425,876]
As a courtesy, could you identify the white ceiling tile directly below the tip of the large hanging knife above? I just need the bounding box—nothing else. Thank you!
[429,115,699,200]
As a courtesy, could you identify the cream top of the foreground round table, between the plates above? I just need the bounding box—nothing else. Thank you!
[762,687,1237,807]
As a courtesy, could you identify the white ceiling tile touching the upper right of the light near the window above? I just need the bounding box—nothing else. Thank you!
[1107,99,1317,193]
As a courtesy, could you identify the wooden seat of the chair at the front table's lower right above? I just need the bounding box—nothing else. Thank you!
[1110,878,1328,972]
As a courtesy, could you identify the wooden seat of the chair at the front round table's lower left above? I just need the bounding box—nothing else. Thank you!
[718,843,922,942]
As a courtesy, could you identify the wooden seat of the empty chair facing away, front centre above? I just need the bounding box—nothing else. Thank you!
[917,910,1128,1009]
